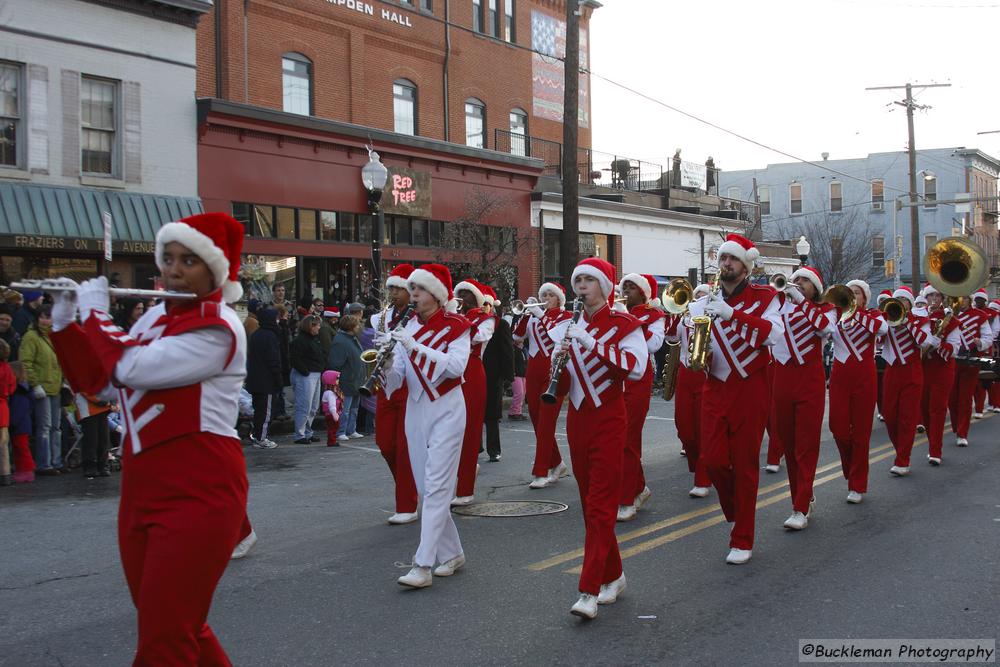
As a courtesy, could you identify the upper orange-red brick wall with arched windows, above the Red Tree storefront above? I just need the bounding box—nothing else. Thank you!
[197,0,593,148]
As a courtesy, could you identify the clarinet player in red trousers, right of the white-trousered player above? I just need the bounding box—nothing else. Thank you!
[553,257,649,619]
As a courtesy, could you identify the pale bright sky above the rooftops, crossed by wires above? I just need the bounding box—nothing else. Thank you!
[590,0,1000,175]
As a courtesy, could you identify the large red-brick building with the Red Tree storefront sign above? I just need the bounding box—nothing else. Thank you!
[197,0,599,303]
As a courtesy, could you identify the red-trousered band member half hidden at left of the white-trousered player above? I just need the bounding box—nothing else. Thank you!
[371,264,419,525]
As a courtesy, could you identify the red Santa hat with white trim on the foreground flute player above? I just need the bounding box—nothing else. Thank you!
[156,213,244,303]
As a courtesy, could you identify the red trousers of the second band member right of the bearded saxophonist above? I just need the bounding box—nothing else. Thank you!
[830,357,877,493]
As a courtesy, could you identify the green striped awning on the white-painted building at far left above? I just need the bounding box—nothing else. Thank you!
[0,181,203,241]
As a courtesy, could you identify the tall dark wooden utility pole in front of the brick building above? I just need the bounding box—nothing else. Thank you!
[559,0,580,284]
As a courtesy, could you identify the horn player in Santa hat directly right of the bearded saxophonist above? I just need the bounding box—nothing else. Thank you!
[771,266,837,530]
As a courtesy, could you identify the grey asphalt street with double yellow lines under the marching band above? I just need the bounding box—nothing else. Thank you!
[0,397,1000,667]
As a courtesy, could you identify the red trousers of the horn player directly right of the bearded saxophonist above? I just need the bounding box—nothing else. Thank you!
[771,356,826,514]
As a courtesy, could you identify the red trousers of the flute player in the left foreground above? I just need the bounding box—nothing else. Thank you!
[118,433,247,667]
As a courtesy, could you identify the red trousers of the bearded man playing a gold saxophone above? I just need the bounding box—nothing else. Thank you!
[701,369,771,549]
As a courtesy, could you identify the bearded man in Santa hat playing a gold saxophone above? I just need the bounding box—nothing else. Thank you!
[688,234,783,565]
